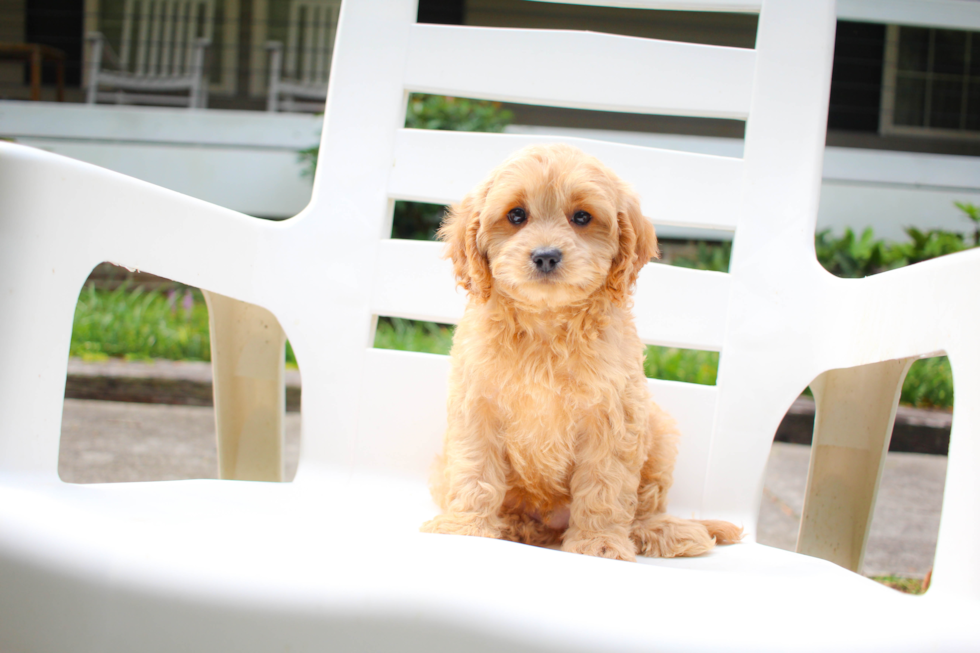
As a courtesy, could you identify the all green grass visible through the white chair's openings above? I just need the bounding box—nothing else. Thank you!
[71,285,953,408]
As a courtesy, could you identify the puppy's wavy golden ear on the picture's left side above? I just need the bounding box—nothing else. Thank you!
[436,180,493,302]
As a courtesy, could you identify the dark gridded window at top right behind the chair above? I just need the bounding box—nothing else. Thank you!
[881,25,980,137]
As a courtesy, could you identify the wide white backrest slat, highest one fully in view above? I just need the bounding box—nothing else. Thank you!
[405,24,755,119]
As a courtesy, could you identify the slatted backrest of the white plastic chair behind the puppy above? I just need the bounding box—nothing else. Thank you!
[302,2,834,523]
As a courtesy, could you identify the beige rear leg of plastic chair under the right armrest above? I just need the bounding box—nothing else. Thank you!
[796,358,916,572]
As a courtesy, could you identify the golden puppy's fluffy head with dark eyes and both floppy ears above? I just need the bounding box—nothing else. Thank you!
[440,145,657,308]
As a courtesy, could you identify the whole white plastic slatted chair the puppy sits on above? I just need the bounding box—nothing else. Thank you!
[0,0,980,653]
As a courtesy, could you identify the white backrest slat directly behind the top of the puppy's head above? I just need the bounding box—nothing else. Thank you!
[388,129,743,231]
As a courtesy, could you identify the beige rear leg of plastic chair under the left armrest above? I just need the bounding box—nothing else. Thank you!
[204,291,286,481]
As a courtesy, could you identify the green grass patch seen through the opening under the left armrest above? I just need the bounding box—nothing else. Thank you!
[70,284,211,361]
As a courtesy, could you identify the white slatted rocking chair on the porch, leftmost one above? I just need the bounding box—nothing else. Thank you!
[86,0,214,109]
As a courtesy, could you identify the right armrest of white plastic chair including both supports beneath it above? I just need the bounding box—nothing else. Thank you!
[798,248,980,597]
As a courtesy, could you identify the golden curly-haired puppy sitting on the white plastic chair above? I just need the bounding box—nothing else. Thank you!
[422,145,741,560]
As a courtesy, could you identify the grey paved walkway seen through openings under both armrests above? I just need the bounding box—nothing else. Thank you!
[58,399,946,576]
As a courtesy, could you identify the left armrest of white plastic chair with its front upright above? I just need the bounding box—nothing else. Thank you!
[0,143,282,475]
